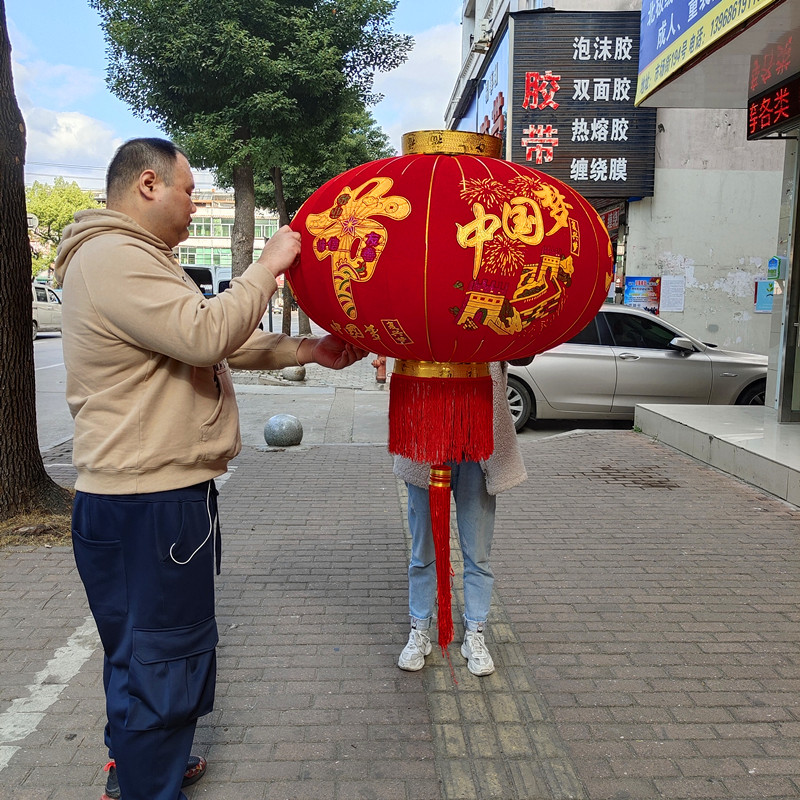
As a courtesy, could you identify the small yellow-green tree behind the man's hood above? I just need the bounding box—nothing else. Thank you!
[25,178,100,282]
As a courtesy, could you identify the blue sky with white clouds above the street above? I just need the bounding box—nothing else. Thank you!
[5,0,462,189]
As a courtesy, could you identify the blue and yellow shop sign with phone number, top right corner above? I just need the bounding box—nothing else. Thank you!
[636,0,782,105]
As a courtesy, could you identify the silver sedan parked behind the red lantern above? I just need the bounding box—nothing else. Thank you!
[508,305,767,430]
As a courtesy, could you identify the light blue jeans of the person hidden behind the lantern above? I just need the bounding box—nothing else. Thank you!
[406,461,496,631]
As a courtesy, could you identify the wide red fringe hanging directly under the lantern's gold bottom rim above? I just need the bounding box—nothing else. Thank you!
[389,373,494,464]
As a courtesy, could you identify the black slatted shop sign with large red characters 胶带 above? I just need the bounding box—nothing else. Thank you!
[509,12,655,198]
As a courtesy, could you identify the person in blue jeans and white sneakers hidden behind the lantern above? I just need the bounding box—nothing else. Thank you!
[394,358,533,675]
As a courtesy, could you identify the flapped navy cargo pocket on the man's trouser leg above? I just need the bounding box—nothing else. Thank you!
[125,617,219,731]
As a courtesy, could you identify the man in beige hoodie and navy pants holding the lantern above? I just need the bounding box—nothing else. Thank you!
[56,139,366,800]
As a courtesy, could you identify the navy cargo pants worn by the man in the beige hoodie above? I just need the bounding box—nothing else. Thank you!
[72,481,219,800]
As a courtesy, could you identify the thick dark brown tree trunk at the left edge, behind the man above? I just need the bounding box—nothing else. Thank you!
[0,0,71,519]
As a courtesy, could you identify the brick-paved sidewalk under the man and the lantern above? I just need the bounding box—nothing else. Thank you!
[0,361,800,800]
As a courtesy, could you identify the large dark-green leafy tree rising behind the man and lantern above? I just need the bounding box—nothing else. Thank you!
[90,0,412,282]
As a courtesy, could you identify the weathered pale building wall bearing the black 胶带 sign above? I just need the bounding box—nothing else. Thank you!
[445,0,785,353]
